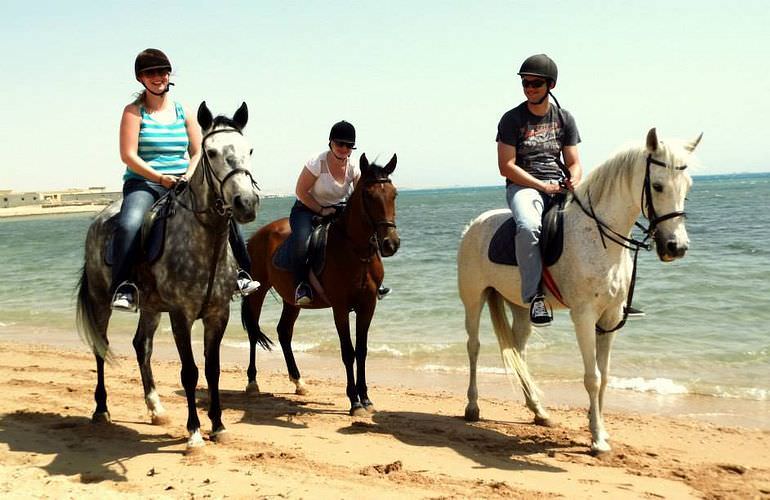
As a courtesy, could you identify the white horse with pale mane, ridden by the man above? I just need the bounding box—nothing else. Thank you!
[457,129,702,453]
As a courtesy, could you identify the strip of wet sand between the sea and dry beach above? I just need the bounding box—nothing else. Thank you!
[0,328,770,431]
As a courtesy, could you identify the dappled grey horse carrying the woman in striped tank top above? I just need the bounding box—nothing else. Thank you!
[77,102,259,449]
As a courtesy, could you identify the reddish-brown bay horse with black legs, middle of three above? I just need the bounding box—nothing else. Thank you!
[241,155,401,416]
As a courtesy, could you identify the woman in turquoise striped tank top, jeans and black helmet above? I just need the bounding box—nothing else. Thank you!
[111,49,259,311]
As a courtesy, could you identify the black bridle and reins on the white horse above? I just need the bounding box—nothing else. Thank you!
[557,154,687,334]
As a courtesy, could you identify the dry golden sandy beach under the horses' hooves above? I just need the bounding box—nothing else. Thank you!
[0,333,770,498]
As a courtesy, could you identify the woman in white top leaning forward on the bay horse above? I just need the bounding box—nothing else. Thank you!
[289,120,361,306]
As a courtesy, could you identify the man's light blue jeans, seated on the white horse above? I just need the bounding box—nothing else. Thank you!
[505,184,553,304]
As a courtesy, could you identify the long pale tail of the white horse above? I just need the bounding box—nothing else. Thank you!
[487,288,540,401]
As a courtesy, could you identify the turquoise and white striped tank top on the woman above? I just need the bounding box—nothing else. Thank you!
[123,102,190,181]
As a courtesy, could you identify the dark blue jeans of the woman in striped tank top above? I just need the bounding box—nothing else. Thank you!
[110,179,251,293]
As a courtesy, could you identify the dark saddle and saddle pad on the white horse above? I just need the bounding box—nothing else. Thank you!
[488,195,566,267]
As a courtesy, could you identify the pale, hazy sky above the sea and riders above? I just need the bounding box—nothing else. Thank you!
[0,0,770,193]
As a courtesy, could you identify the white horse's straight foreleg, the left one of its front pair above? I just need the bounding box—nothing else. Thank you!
[571,309,611,453]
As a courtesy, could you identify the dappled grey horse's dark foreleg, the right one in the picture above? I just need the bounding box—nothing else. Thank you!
[203,307,225,441]
